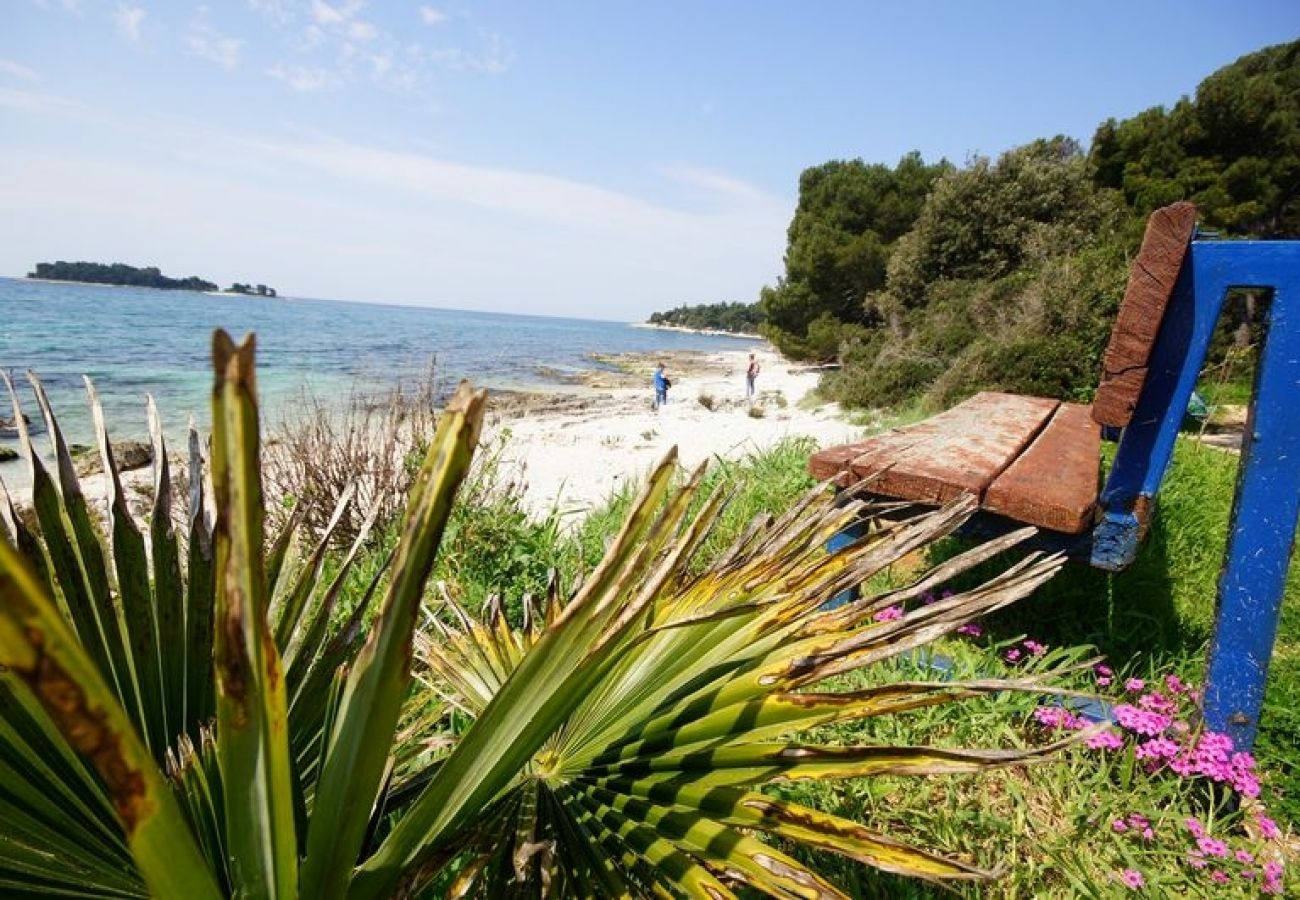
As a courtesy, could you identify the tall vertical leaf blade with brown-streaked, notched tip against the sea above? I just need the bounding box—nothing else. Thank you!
[212,332,298,897]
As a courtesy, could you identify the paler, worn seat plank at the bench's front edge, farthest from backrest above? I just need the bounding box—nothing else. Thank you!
[850,391,1060,503]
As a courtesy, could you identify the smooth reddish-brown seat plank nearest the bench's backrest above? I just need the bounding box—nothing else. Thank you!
[983,403,1101,535]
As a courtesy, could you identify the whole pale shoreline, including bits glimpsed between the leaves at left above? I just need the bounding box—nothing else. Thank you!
[0,349,861,520]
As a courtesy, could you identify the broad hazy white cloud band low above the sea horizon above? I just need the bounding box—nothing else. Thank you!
[0,118,793,321]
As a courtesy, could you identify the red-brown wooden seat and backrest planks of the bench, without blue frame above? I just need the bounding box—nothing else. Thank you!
[809,203,1196,535]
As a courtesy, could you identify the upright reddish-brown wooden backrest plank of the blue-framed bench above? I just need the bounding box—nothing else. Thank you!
[1092,203,1196,427]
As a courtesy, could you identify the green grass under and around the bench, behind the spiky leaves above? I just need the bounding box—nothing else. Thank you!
[356,426,1300,897]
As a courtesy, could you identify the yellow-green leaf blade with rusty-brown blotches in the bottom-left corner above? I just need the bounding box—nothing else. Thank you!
[0,530,218,899]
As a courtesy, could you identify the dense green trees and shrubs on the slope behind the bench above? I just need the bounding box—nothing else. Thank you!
[759,42,1300,407]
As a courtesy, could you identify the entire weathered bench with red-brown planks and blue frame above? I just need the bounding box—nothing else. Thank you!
[809,203,1300,749]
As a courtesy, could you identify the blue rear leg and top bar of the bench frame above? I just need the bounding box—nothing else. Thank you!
[1192,241,1300,749]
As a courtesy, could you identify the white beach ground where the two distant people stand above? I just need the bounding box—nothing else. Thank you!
[488,349,861,518]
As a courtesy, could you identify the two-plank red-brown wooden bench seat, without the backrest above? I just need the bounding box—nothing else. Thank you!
[809,391,1101,535]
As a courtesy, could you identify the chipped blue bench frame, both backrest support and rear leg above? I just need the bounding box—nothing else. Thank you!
[1092,235,1300,749]
